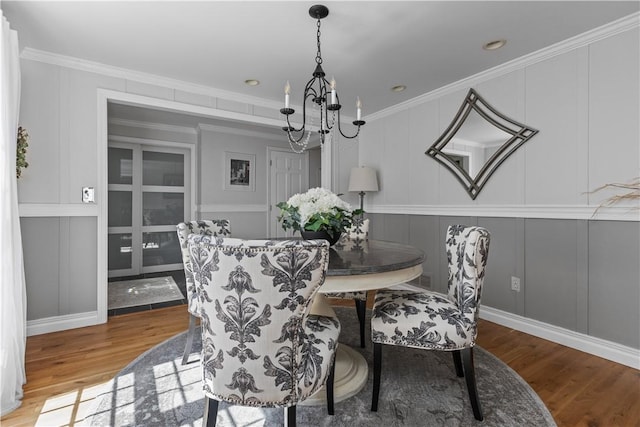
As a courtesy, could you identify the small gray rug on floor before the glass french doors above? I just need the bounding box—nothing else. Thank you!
[108,276,184,310]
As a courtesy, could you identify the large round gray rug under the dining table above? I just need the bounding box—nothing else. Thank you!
[85,307,556,427]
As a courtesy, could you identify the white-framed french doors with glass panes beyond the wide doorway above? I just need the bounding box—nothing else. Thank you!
[108,143,191,277]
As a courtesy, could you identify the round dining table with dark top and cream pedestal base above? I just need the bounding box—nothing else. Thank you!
[300,239,424,405]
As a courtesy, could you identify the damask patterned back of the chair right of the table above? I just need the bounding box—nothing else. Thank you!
[446,225,490,324]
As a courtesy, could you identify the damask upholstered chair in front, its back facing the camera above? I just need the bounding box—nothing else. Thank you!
[189,235,340,426]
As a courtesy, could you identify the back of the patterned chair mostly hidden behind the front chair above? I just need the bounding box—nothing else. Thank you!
[176,219,231,316]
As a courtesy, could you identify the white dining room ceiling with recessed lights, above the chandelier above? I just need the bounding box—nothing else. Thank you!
[1,0,640,119]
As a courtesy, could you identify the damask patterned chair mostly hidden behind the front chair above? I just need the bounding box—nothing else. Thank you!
[176,219,231,365]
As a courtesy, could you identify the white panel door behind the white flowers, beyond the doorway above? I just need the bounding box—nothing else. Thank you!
[268,149,309,237]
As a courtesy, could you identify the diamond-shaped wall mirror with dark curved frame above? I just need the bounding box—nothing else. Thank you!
[425,89,538,200]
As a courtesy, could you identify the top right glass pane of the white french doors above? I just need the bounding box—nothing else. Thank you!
[142,151,184,187]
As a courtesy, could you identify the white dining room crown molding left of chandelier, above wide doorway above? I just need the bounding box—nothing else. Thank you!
[20,47,281,109]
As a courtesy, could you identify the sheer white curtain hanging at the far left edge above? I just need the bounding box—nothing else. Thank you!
[0,10,27,415]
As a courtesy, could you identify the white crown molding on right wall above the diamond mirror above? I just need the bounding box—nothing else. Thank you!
[367,12,640,122]
